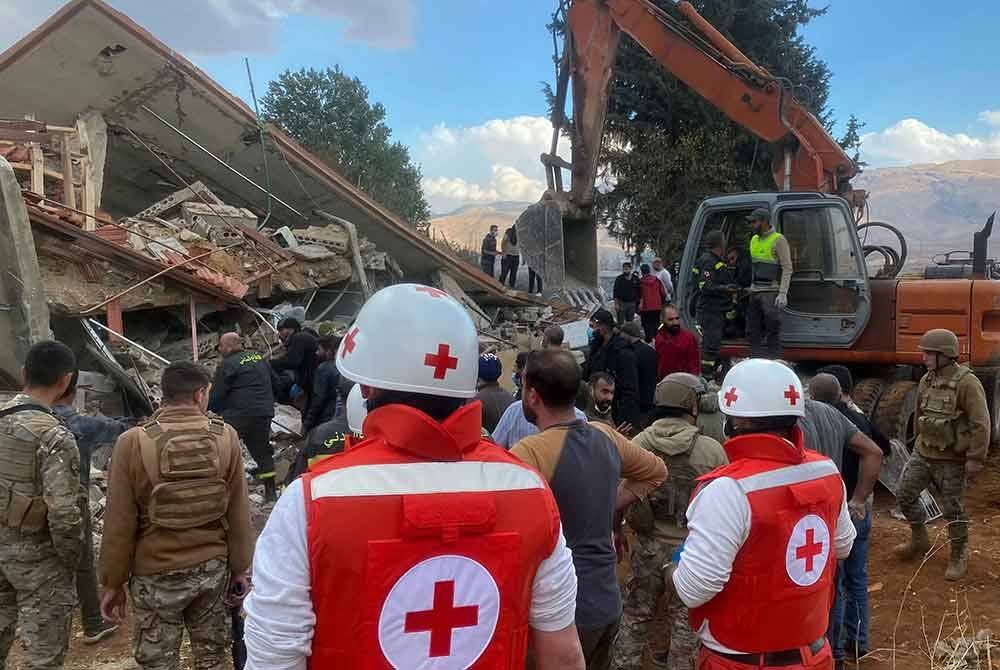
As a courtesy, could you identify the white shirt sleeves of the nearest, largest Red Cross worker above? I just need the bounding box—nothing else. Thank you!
[244,480,576,670]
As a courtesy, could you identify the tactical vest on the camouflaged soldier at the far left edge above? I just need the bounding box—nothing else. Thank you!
[0,404,62,533]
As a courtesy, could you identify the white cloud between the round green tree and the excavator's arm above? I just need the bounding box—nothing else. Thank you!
[413,116,556,211]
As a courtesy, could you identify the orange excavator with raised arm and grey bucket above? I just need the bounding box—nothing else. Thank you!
[517,0,1000,444]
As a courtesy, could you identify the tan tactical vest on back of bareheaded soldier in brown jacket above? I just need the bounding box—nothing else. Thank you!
[139,418,231,530]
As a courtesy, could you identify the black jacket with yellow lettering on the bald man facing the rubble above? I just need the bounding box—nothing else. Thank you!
[208,351,274,420]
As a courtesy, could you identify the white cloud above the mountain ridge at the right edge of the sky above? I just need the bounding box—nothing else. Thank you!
[861,118,1000,166]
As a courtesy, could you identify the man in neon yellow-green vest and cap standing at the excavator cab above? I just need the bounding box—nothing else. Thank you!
[747,207,792,359]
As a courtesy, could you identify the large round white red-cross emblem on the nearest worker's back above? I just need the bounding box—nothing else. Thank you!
[378,555,500,670]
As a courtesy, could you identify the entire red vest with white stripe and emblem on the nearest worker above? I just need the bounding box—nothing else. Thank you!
[302,402,560,670]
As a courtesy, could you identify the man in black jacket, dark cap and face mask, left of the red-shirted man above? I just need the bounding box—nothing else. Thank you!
[586,308,639,436]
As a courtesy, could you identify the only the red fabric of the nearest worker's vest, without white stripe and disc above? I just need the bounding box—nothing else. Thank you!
[303,402,559,670]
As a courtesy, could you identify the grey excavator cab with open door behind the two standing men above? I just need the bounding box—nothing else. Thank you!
[677,192,871,348]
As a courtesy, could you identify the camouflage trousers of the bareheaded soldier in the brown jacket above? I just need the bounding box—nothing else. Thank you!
[129,560,230,670]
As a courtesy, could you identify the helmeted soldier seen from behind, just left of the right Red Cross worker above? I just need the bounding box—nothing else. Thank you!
[614,372,728,670]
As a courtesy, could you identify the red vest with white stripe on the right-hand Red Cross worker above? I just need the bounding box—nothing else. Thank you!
[682,431,844,653]
